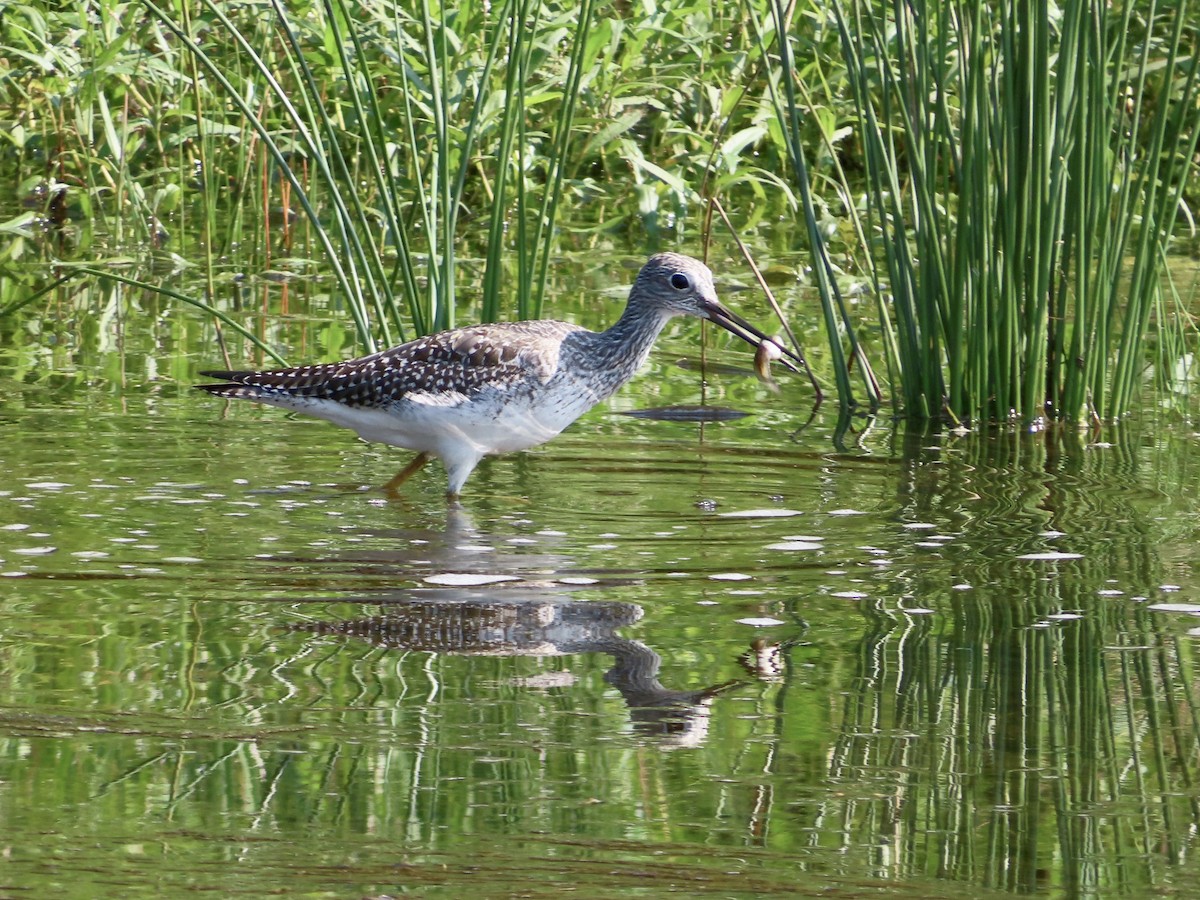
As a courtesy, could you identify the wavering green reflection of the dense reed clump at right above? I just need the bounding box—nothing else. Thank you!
[827,431,1200,896]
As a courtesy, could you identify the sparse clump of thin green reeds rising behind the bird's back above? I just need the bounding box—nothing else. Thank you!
[109,0,609,349]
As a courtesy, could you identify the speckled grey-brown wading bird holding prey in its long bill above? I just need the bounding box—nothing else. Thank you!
[196,253,804,500]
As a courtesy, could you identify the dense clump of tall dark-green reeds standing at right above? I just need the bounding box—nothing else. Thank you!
[820,0,1200,425]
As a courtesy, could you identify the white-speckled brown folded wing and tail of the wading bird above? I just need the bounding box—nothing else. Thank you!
[196,320,581,407]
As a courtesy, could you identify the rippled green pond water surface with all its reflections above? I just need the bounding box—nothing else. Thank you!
[0,307,1200,896]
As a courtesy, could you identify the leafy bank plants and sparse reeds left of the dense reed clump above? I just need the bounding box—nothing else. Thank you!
[0,0,825,360]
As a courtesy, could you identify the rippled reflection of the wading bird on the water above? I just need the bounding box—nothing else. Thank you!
[284,508,790,748]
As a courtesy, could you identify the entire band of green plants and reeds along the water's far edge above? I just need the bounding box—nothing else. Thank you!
[0,0,1200,424]
